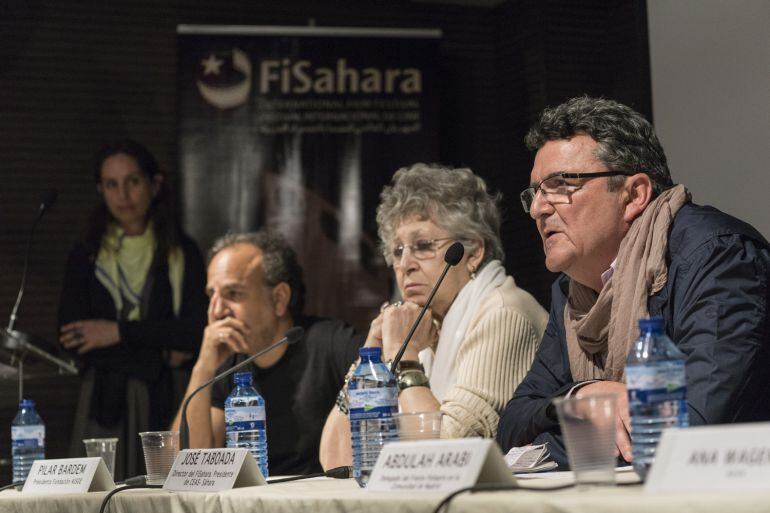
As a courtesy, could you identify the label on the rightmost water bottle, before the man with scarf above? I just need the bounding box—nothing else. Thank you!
[626,360,687,404]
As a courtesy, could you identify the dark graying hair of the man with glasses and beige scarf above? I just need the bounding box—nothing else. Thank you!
[524,96,673,196]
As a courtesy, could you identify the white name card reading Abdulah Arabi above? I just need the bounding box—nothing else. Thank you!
[366,438,516,493]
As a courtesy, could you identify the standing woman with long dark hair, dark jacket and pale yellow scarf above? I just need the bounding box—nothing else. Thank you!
[59,140,207,480]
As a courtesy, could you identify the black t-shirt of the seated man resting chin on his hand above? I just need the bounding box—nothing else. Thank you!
[211,317,364,476]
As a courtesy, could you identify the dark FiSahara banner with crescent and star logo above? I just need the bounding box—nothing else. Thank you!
[178,26,440,327]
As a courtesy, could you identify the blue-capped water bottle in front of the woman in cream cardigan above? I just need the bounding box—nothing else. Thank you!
[348,347,398,487]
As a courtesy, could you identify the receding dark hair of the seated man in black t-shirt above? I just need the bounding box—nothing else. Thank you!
[209,230,305,321]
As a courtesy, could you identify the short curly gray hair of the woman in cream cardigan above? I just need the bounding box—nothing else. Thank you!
[377,164,505,267]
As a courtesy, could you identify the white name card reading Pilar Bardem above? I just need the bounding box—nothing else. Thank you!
[21,458,115,495]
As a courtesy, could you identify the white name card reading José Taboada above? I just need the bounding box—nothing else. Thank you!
[163,449,267,492]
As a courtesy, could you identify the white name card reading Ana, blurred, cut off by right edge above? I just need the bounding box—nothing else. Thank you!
[644,422,770,493]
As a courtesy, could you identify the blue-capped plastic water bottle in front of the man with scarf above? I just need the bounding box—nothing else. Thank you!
[626,317,690,480]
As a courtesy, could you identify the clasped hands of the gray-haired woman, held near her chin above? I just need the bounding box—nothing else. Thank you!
[382,301,438,360]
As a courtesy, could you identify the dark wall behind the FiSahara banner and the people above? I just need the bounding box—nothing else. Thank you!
[0,0,651,474]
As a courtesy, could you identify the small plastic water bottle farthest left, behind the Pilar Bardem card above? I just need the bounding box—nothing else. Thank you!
[11,399,45,483]
